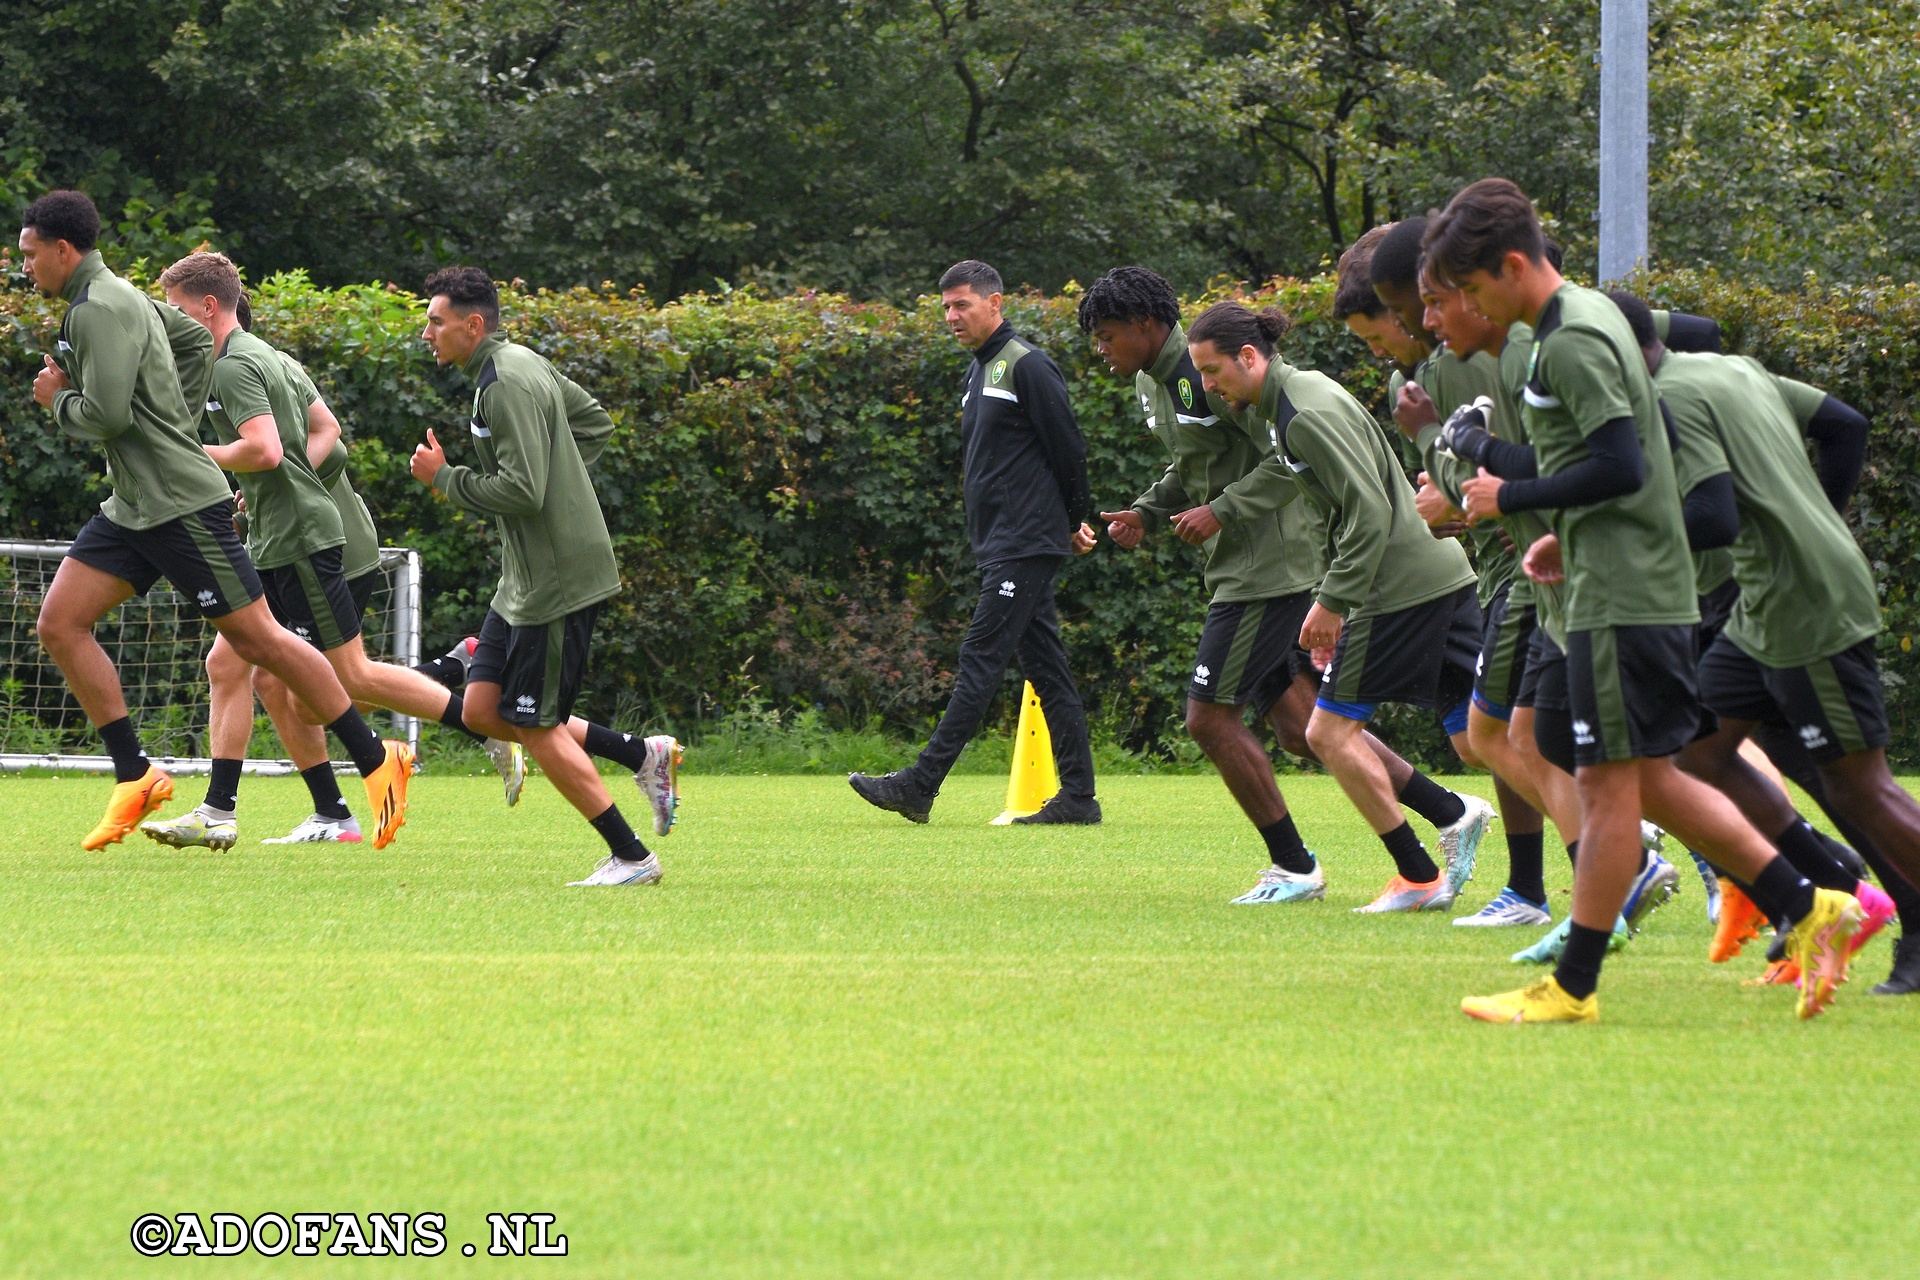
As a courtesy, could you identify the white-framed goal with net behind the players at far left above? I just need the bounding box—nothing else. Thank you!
[0,541,420,773]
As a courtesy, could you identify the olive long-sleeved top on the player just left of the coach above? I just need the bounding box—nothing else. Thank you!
[434,334,620,628]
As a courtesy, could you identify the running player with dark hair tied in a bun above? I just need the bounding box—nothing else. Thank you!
[1188,301,1492,913]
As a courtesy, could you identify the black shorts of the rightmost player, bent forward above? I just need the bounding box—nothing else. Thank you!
[1699,635,1889,764]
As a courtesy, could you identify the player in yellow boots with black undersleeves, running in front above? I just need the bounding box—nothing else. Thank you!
[1428,178,1860,1023]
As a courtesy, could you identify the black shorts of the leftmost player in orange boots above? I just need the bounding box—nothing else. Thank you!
[67,503,265,618]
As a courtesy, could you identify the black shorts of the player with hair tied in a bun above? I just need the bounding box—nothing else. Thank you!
[1319,585,1486,720]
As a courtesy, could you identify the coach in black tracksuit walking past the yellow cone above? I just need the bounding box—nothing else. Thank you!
[847,261,1100,823]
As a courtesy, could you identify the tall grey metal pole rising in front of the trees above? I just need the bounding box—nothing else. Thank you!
[1599,0,1647,282]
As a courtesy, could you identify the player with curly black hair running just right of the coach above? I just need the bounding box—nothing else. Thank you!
[1079,267,1471,904]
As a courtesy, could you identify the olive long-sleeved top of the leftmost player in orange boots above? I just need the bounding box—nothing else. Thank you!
[52,249,232,530]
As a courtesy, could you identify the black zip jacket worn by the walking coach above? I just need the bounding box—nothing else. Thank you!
[960,324,1091,564]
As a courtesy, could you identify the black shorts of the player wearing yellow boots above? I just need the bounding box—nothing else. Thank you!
[1567,622,1699,764]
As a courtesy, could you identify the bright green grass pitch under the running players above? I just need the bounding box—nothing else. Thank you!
[0,777,1920,1280]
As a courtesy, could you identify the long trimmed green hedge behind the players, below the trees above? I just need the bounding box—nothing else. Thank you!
[0,274,1920,764]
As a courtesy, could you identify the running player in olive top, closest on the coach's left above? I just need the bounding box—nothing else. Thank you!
[411,267,680,885]
